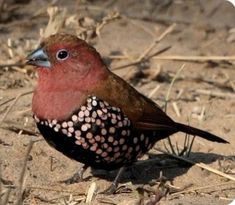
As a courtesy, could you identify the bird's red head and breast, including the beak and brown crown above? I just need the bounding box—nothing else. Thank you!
[27,34,108,119]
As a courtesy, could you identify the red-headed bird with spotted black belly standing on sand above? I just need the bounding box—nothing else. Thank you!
[26,33,228,193]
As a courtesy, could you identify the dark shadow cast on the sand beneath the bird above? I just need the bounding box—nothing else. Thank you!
[85,152,235,184]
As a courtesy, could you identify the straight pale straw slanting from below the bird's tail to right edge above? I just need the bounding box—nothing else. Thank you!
[154,147,235,181]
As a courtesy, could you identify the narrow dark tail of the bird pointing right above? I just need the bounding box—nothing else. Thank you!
[176,123,229,143]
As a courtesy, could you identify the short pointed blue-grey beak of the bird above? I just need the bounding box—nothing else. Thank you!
[26,48,51,68]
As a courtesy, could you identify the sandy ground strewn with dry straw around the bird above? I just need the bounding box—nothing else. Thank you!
[0,0,235,205]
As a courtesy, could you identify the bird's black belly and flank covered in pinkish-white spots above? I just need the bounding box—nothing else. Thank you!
[34,96,161,170]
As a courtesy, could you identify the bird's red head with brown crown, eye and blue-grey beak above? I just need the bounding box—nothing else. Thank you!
[27,34,107,91]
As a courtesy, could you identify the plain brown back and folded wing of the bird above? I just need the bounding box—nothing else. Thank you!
[94,73,177,134]
